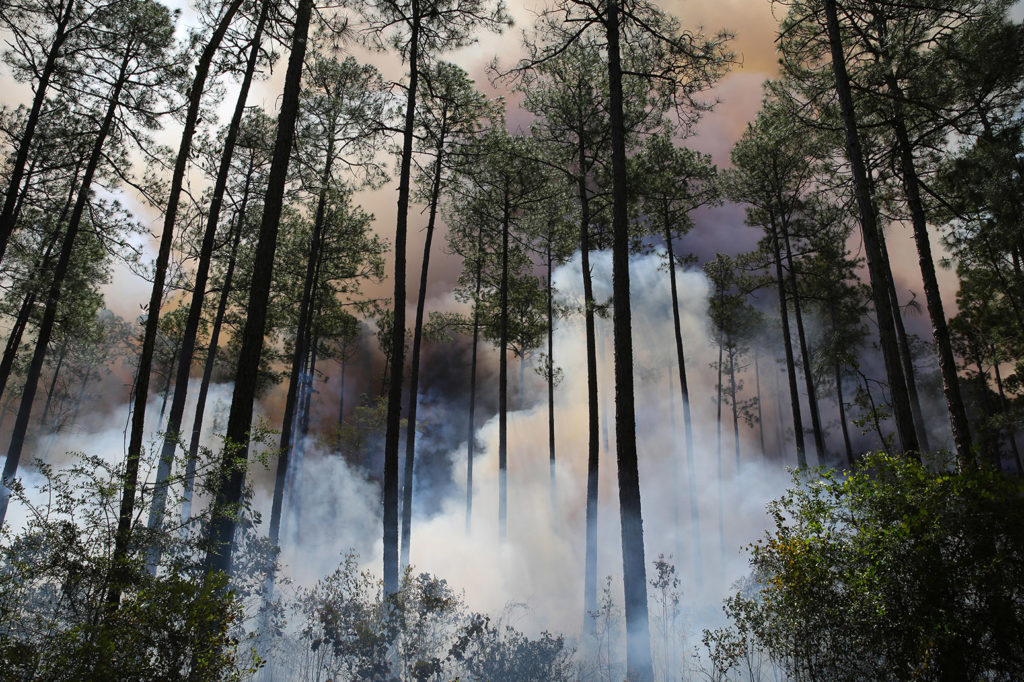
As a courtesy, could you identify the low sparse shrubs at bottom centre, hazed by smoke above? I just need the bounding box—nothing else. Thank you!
[275,553,574,682]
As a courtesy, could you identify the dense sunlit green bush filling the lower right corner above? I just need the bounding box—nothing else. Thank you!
[706,454,1024,680]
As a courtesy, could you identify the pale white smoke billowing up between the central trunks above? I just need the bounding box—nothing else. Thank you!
[256,245,790,646]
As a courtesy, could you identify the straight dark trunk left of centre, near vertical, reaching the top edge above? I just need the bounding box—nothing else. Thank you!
[384,0,420,595]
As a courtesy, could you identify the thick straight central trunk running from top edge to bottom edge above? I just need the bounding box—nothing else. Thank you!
[605,0,654,682]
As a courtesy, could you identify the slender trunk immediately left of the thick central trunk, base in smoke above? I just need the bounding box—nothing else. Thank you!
[578,160,601,641]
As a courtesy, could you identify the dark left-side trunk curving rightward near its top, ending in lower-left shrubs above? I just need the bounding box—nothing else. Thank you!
[106,0,242,608]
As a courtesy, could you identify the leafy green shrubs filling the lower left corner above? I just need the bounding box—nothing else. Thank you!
[0,448,258,682]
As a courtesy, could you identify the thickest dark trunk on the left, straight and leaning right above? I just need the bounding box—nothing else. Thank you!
[200,0,313,574]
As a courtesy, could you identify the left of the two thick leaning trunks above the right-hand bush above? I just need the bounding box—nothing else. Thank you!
[823,0,920,459]
